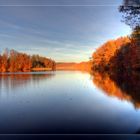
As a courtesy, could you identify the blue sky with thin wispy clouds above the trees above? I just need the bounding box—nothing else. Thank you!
[0,0,131,62]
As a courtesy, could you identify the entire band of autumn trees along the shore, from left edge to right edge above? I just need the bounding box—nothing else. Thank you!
[0,0,140,73]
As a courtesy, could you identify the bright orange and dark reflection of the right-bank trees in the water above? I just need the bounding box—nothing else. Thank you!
[93,72,140,108]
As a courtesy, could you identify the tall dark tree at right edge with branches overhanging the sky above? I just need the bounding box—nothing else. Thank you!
[120,0,140,70]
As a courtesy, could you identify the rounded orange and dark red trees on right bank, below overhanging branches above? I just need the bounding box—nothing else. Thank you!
[92,37,140,72]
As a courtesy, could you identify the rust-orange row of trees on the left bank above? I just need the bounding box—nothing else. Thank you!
[0,49,55,72]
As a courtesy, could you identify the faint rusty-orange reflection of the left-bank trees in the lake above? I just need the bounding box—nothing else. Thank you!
[0,73,54,90]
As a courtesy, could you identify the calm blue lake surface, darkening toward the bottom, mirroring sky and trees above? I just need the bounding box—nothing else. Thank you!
[0,71,140,134]
